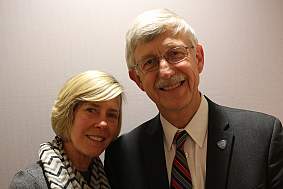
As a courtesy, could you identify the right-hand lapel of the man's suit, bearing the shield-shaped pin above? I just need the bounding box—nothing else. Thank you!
[206,99,234,189]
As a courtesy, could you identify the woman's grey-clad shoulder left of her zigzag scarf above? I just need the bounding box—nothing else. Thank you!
[10,162,48,189]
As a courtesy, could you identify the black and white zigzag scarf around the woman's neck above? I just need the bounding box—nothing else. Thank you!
[39,137,110,189]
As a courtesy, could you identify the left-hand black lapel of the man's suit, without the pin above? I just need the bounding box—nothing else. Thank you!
[142,115,169,189]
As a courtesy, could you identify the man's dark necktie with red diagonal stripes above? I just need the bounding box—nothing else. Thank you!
[171,131,192,189]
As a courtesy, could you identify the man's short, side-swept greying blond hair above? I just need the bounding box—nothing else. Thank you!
[126,9,198,70]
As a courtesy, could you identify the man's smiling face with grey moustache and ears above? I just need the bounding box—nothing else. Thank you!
[129,33,204,115]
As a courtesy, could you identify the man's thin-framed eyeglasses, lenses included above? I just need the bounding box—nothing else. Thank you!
[135,46,194,74]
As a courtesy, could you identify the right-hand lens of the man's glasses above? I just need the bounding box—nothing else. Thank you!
[164,47,188,64]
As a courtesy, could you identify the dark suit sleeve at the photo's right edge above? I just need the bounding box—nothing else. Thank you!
[268,119,283,189]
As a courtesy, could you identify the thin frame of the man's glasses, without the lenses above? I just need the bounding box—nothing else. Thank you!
[133,45,195,74]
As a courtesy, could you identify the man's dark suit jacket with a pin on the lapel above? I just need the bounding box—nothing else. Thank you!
[105,100,283,189]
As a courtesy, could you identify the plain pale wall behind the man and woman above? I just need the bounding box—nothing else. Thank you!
[0,0,283,188]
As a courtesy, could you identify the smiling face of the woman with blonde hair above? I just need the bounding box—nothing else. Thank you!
[69,97,121,158]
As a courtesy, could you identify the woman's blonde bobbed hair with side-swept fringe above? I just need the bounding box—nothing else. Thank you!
[51,70,123,140]
